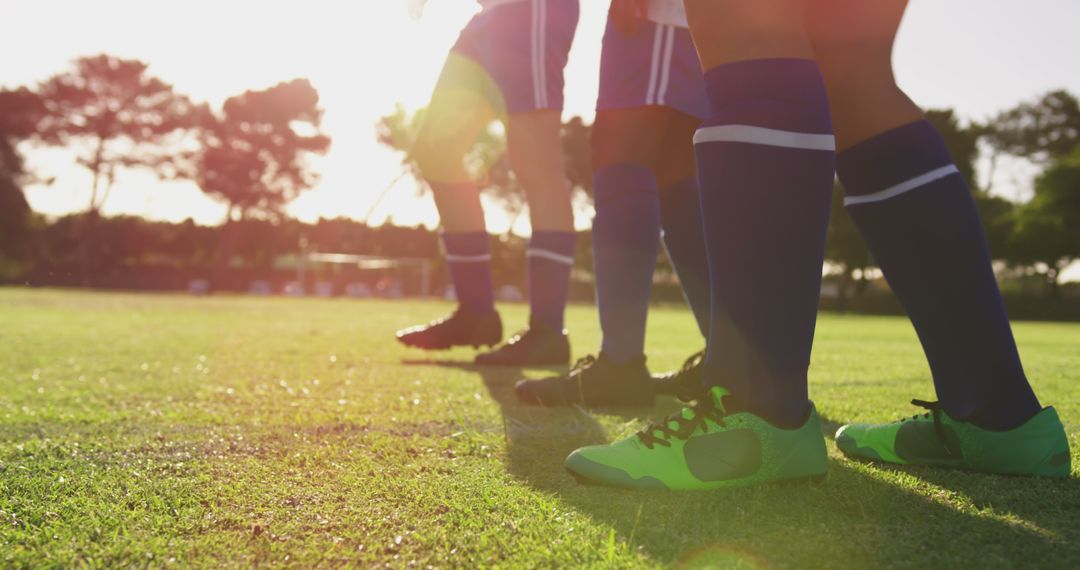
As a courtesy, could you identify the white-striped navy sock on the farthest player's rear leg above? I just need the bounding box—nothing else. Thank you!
[528,231,577,330]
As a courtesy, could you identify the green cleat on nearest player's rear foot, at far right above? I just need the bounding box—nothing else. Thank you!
[836,399,1071,477]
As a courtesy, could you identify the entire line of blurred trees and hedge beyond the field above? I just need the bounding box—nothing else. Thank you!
[0,55,1080,298]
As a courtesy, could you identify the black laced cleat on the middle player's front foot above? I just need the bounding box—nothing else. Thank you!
[514,353,654,407]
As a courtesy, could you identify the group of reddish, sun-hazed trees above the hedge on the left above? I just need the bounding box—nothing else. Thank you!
[0,55,330,285]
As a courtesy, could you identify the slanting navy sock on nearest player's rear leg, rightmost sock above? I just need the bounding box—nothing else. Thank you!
[837,121,1040,429]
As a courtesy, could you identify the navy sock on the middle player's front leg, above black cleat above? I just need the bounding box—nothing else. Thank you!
[593,163,660,363]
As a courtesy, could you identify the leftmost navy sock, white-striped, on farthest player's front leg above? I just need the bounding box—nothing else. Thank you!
[443,232,495,314]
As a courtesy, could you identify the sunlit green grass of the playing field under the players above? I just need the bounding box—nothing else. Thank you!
[0,289,1080,568]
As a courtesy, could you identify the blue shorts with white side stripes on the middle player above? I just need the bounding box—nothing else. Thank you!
[596,21,708,119]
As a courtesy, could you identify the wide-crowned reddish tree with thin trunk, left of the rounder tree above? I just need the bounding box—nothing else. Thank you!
[39,55,205,216]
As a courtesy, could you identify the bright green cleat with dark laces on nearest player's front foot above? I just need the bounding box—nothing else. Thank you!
[566,388,827,491]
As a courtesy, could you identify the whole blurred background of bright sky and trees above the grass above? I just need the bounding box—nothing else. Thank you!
[0,0,1080,320]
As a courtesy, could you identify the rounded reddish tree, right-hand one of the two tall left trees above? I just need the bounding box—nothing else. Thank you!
[193,79,330,221]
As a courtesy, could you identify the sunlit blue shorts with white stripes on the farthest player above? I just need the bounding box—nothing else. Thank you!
[453,0,579,113]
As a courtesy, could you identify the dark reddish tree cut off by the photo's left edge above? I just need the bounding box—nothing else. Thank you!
[0,89,43,279]
